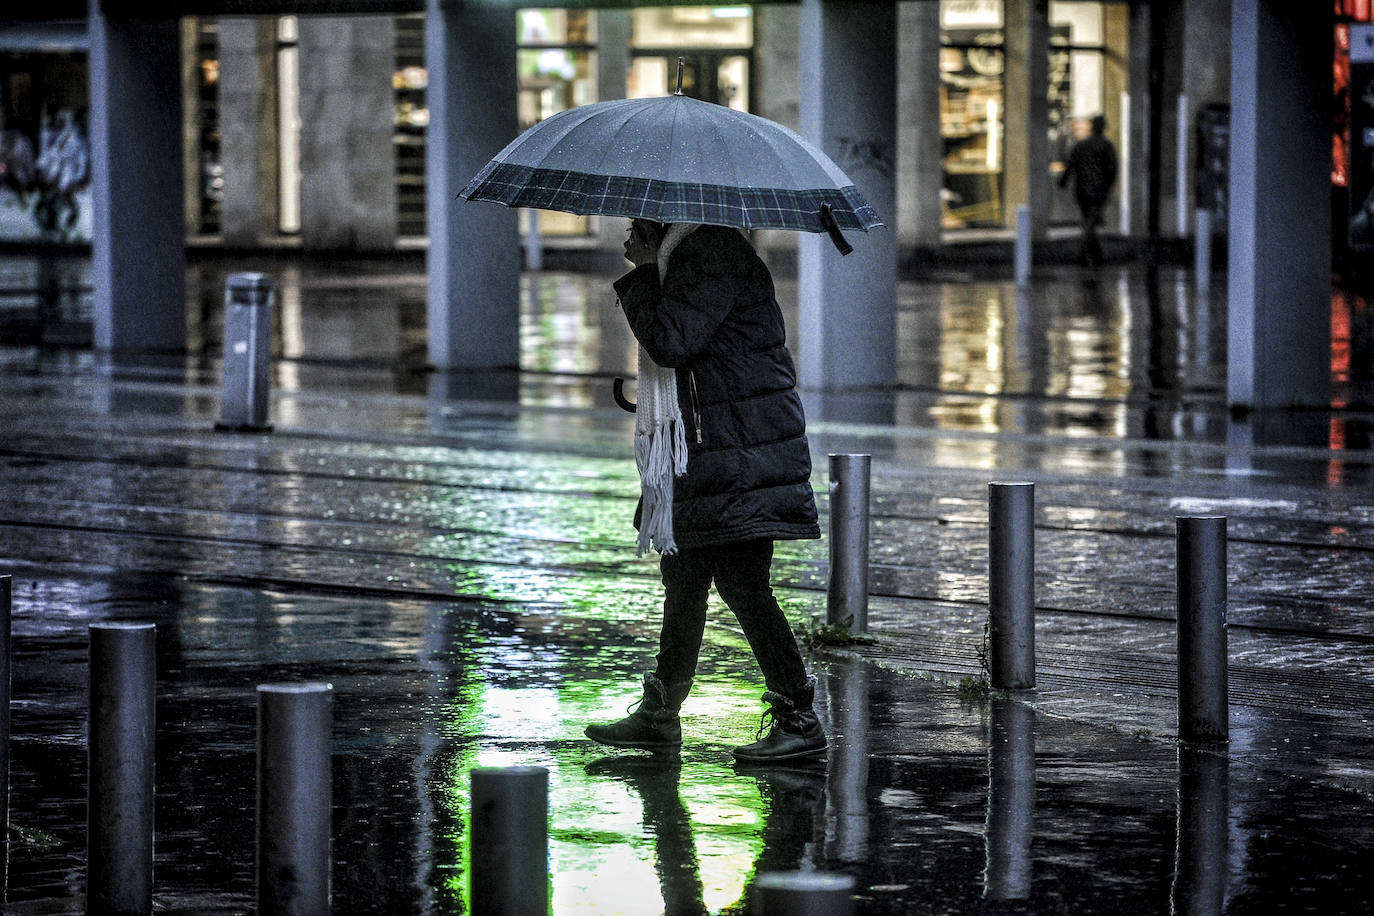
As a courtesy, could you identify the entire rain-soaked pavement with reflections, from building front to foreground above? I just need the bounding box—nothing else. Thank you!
[0,247,1374,915]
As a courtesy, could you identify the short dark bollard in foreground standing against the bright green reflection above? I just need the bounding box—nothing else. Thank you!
[469,766,548,916]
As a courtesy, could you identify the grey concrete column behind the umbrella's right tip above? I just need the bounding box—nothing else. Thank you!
[798,0,897,391]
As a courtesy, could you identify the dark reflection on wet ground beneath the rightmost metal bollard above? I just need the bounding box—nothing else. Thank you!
[1169,744,1231,916]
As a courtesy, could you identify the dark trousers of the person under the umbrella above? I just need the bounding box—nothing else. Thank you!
[655,538,807,695]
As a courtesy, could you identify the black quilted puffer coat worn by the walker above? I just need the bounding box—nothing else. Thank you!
[616,225,820,548]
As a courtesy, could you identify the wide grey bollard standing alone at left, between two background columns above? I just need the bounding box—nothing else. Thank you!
[214,273,272,431]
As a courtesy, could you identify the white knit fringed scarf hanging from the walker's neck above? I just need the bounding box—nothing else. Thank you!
[635,222,698,556]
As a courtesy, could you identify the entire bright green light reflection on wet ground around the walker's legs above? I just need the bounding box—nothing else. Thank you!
[426,436,797,916]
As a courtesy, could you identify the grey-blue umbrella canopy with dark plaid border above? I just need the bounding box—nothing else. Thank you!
[459,95,882,234]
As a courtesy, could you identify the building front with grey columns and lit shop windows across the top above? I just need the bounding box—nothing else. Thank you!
[0,0,1352,408]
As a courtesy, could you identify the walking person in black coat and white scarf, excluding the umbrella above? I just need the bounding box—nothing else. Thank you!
[587,220,826,762]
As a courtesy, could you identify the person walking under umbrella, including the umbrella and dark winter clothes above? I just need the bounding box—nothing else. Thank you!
[460,66,882,762]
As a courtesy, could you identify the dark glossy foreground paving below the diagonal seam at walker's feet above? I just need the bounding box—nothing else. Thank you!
[0,577,1374,913]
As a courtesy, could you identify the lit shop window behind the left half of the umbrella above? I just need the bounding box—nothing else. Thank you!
[515,10,596,236]
